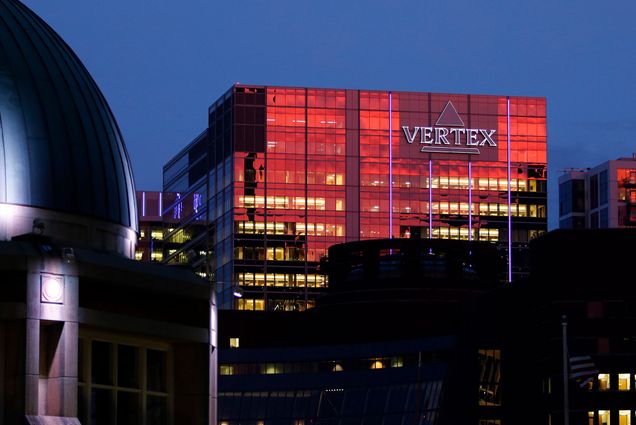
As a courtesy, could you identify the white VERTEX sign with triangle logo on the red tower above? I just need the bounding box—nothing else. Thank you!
[402,101,497,154]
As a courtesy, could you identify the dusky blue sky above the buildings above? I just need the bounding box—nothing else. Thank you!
[19,0,636,228]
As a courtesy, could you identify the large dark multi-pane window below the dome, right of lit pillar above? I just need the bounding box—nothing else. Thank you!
[78,337,172,425]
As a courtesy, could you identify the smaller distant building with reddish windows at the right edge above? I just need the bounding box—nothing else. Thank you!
[559,155,636,229]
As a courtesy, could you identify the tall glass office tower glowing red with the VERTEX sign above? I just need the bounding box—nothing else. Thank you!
[163,84,547,310]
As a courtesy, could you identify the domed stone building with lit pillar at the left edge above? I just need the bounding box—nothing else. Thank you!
[0,0,216,425]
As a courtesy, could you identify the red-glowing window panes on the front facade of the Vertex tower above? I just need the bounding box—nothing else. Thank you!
[209,87,546,312]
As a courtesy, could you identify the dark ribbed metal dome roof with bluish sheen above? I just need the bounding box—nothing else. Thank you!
[0,0,137,230]
